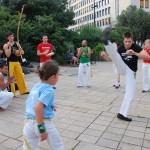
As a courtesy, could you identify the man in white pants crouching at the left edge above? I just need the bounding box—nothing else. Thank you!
[0,63,15,111]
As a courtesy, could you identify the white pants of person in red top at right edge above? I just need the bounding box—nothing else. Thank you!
[142,63,150,91]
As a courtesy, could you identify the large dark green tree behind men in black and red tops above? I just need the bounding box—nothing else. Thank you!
[0,0,74,61]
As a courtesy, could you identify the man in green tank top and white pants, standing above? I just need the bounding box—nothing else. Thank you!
[77,40,91,88]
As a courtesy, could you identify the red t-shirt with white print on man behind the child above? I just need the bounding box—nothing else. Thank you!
[37,43,53,63]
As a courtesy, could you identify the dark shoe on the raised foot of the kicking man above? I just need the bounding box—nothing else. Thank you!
[101,27,111,45]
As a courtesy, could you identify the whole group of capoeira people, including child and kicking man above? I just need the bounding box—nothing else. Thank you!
[0,28,150,150]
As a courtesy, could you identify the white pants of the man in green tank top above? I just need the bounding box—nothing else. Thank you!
[78,62,91,86]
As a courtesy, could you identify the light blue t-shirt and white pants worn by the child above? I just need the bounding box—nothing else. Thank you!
[23,82,64,150]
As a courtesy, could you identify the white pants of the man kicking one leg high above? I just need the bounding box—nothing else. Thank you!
[105,44,136,117]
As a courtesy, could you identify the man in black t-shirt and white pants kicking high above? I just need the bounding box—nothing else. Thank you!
[102,28,150,121]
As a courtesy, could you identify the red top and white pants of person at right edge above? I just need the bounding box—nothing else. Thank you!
[142,48,150,91]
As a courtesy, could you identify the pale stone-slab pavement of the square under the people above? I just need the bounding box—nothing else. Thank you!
[0,62,150,150]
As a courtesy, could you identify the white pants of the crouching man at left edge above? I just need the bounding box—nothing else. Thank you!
[0,91,14,109]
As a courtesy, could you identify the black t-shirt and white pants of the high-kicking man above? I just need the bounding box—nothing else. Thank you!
[105,43,142,117]
